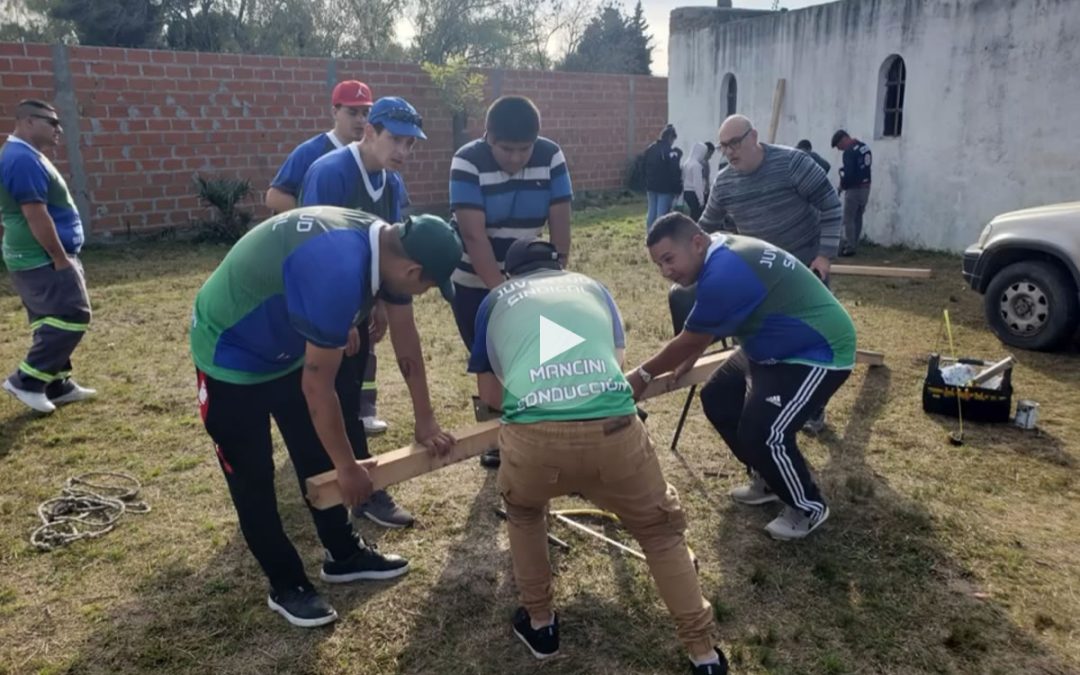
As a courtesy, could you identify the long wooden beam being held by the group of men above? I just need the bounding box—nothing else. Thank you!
[307,350,885,509]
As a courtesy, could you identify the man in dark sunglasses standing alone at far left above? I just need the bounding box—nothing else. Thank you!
[0,99,97,413]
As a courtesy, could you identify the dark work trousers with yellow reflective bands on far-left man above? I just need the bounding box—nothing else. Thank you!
[9,256,91,399]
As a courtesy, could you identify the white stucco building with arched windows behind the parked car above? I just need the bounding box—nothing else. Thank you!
[669,0,1080,251]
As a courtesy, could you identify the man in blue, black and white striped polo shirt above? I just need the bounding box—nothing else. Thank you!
[450,96,573,468]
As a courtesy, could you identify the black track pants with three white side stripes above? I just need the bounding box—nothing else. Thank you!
[701,349,851,515]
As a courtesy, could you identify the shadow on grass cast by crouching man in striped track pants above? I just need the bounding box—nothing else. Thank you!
[714,368,1068,674]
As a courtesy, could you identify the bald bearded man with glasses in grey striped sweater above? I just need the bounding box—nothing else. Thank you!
[698,114,843,280]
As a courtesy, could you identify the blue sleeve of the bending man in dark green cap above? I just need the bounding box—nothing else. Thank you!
[283,230,370,348]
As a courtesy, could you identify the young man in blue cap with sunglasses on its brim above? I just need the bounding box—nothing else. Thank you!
[300,96,427,527]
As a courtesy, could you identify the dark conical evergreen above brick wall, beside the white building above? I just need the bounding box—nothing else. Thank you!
[559,2,652,75]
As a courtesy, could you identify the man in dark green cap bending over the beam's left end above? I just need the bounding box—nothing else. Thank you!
[191,206,462,627]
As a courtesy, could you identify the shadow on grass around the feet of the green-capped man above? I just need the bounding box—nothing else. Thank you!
[62,453,407,675]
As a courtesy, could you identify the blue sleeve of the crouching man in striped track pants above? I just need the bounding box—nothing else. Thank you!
[686,251,768,337]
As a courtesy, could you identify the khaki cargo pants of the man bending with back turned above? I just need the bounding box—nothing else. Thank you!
[499,416,715,654]
